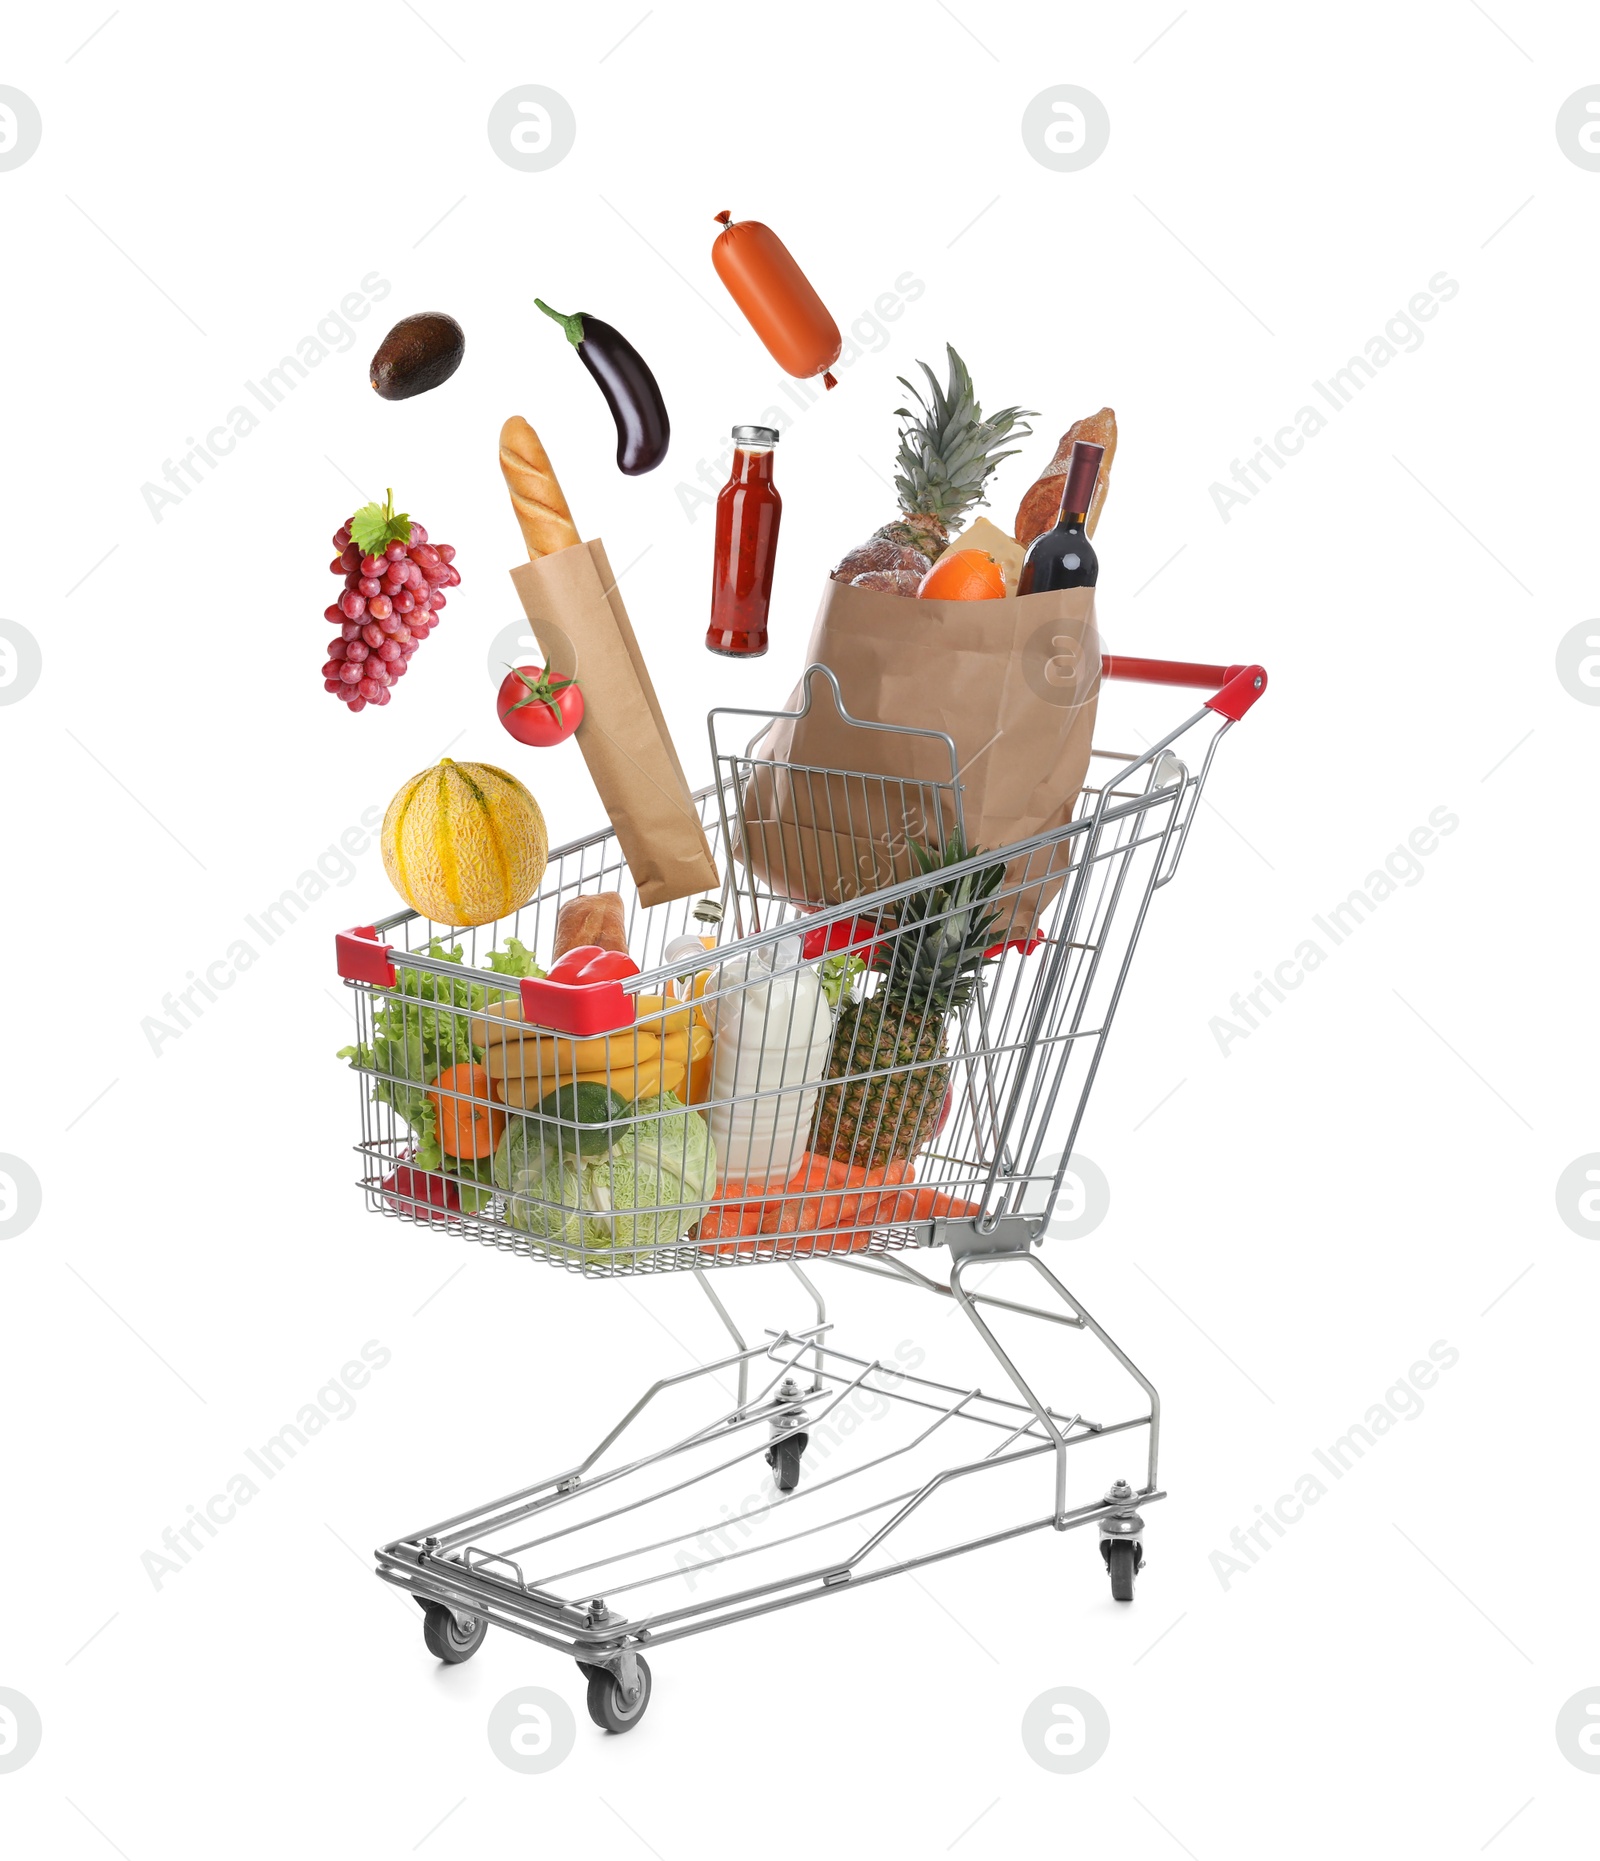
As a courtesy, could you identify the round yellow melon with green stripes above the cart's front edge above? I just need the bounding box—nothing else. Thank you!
[383,756,551,929]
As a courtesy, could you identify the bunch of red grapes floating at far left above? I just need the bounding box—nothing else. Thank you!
[322,517,461,711]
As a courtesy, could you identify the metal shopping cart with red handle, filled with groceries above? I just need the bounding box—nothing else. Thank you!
[339,655,1267,1733]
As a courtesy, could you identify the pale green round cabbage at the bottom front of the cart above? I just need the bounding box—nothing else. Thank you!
[495,1092,716,1251]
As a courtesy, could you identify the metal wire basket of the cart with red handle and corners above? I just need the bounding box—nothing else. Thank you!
[339,659,1265,1277]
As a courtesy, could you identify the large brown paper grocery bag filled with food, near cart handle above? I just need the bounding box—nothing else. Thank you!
[740,582,1100,908]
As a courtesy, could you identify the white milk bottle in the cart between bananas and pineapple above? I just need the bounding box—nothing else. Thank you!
[701,936,833,1184]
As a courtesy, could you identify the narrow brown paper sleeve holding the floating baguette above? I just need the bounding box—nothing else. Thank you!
[512,540,722,904]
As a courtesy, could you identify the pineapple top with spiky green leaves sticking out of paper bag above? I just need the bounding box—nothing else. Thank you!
[833,342,1033,582]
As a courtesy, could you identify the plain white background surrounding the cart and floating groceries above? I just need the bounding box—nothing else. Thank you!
[0,0,1600,1861]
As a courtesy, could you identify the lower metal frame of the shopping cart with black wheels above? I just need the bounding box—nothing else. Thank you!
[376,1245,1167,1731]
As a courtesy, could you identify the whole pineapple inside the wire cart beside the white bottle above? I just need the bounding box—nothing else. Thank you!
[811,836,1005,1169]
